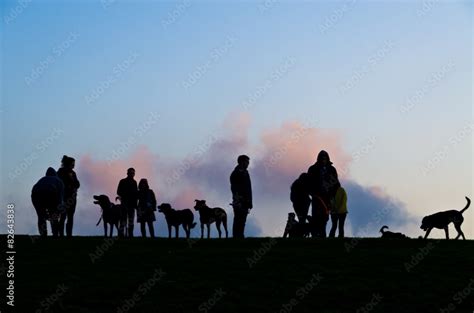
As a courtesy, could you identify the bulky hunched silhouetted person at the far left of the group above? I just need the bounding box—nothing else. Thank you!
[31,167,64,237]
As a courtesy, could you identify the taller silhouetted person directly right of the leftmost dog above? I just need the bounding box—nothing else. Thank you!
[117,168,138,237]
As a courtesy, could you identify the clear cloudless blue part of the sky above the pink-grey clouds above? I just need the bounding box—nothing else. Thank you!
[0,0,474,238]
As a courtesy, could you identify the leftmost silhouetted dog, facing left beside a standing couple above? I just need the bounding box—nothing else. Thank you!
[94,195,126,237]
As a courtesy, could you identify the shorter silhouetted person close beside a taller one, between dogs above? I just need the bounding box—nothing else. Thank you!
[137,178,156,238]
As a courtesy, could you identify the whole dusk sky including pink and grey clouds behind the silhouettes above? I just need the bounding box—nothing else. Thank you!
[0,0,474,238]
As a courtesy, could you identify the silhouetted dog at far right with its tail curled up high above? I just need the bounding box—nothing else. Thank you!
[420,197,471,240]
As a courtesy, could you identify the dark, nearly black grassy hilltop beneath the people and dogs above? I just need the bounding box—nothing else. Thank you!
[1,236,474,313]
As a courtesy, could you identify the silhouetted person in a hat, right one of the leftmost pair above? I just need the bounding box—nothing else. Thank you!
[58,155,80,237]
